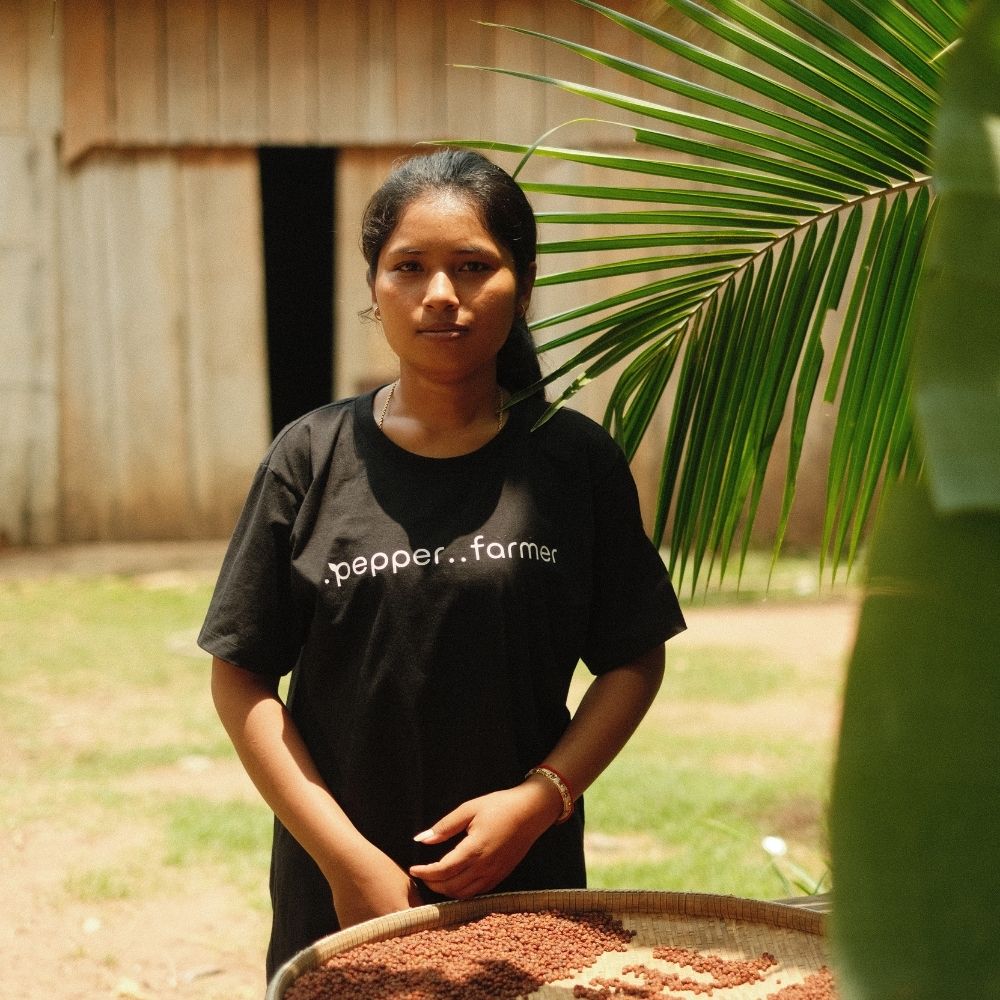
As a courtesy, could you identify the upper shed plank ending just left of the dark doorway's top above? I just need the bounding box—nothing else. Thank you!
[216,0,267,144]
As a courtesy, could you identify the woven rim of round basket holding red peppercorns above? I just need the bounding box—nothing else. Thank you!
[264,889,825,1000]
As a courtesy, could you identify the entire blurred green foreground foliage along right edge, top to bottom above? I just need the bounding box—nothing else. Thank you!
[830,0,1000,1000]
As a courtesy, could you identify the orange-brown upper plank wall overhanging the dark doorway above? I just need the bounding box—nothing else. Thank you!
[63,0,650,160]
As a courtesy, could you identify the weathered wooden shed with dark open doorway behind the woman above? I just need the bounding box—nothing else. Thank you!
[0,0,828,544]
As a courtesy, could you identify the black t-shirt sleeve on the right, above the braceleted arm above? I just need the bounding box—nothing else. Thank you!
[582,445,687,674]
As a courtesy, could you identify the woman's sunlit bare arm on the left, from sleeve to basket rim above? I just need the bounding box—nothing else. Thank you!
[212,657,422,927]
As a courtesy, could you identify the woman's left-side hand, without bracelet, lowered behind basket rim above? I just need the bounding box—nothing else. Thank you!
[327,841,423,928]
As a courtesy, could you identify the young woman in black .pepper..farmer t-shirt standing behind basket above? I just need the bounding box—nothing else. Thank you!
[199,150,684,975]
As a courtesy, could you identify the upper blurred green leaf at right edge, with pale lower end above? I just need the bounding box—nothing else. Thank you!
[914,5,1000,512]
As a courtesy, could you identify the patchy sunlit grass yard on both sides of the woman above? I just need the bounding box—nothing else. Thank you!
[0,560,839,924]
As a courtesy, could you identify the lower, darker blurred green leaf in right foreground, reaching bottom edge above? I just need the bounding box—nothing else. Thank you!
[830,480,1000,1000]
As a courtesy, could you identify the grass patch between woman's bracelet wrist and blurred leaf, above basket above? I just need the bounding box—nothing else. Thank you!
[587,733,828,899]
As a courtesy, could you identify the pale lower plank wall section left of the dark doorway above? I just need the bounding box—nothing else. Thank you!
[60,150,270,539]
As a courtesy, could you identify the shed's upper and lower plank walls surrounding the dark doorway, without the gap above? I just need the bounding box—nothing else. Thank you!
[41,0,680,539]
